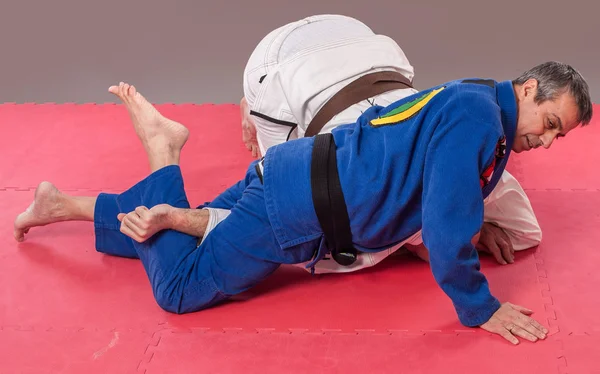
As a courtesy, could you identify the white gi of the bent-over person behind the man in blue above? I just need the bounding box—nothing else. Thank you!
[205,15,542,273]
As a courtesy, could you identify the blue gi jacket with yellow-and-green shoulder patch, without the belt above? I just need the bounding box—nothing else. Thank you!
[264,78,517,326]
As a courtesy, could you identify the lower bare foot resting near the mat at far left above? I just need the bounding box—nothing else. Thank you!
[13,182,67,242]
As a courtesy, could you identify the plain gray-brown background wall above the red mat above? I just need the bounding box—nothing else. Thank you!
[0,0,600,103]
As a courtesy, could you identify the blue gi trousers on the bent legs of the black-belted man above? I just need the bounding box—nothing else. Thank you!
[94,162,321,313]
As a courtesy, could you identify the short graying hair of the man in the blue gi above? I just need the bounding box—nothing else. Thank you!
[513,61,593,126]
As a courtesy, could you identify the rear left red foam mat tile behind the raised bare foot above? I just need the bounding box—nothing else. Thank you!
[0,104,251,196]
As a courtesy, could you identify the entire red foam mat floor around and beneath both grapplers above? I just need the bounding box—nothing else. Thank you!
[0,104,600,373]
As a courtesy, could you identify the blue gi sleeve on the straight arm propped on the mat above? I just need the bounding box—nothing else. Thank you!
[422,114,500,327]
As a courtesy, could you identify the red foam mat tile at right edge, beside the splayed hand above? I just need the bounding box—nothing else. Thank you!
[529,191,600,334]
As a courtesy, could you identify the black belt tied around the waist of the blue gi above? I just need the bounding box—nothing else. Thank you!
[310,134,357,266]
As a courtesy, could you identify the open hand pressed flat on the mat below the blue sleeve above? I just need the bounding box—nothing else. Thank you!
[480,303,548,344]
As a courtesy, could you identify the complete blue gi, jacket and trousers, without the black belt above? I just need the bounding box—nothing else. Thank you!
[94,79,517,326]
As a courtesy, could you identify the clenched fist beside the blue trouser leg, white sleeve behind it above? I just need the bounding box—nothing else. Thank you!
[117,204,173,243]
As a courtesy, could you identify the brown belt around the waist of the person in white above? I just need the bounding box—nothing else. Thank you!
[304,71,413,137]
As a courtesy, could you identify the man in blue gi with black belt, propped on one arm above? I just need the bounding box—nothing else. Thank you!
[15,62,592,344]
